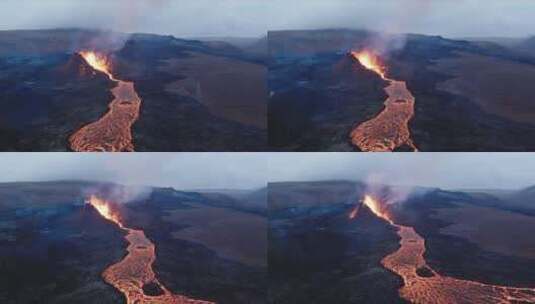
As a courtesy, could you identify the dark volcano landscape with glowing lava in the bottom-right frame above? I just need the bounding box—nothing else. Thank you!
[269,181,535,303]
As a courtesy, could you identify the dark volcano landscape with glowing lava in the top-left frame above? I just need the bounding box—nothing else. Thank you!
[0,30,267,152]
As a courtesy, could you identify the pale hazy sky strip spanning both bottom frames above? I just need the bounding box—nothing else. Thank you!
[0,153,535,189]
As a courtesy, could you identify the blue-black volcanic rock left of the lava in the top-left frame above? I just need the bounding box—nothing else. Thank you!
[0,54,113,151]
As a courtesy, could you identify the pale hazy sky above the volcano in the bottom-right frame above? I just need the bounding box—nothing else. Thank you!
[268,153,535,189]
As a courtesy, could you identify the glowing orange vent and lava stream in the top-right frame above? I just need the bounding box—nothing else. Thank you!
[350,50,418,152]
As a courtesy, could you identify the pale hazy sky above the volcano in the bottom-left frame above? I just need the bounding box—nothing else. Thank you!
[0,153,266,189]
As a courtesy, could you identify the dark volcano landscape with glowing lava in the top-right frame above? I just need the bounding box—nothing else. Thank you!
[268,29,535,152]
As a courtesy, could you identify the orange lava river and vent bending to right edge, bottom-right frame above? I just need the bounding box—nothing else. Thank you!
[350,196,535,304]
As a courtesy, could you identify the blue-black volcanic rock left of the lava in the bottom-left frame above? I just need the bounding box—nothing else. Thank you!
[0,182,126,304]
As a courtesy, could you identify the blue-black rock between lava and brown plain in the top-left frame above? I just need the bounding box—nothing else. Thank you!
[113,31,267,152]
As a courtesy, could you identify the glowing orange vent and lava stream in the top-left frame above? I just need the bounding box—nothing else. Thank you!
[69,51,141,152]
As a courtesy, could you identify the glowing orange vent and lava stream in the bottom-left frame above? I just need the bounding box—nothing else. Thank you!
[87,195,213,304]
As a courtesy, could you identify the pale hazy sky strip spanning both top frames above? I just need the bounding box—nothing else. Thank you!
[0,0,535,37]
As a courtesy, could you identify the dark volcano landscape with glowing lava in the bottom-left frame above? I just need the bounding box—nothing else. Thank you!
[0,181,267,304]
